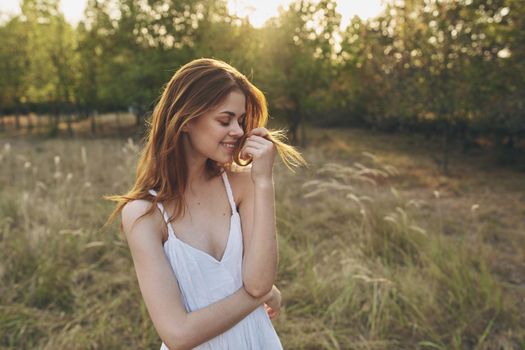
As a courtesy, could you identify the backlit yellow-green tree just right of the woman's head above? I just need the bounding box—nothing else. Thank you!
[261,0,340,145]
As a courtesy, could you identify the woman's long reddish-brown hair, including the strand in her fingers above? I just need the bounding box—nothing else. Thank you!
[105,58,306,224]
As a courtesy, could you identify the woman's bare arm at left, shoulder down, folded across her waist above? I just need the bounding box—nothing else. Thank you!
[122,200,271,350]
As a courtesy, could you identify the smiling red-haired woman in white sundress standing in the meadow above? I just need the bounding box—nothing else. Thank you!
[108,59,304,350]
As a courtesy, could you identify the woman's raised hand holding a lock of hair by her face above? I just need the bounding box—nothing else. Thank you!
[241,128,275,184]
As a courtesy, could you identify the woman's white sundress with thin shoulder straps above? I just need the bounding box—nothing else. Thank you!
[150,172,283,350]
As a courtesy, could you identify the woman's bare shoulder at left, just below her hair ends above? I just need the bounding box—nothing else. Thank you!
[121,199,163,242]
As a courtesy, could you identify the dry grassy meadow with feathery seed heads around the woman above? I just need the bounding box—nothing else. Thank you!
[0,129,525,350]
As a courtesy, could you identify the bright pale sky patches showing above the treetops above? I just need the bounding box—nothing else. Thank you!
[0,0,382,27]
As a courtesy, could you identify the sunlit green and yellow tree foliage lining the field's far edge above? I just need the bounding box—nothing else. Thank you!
[0,0,525,163]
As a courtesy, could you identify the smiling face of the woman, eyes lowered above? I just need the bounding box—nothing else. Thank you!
[183,90,246,164]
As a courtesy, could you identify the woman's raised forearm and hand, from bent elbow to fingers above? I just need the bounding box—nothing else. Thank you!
[239,128,278,297]
